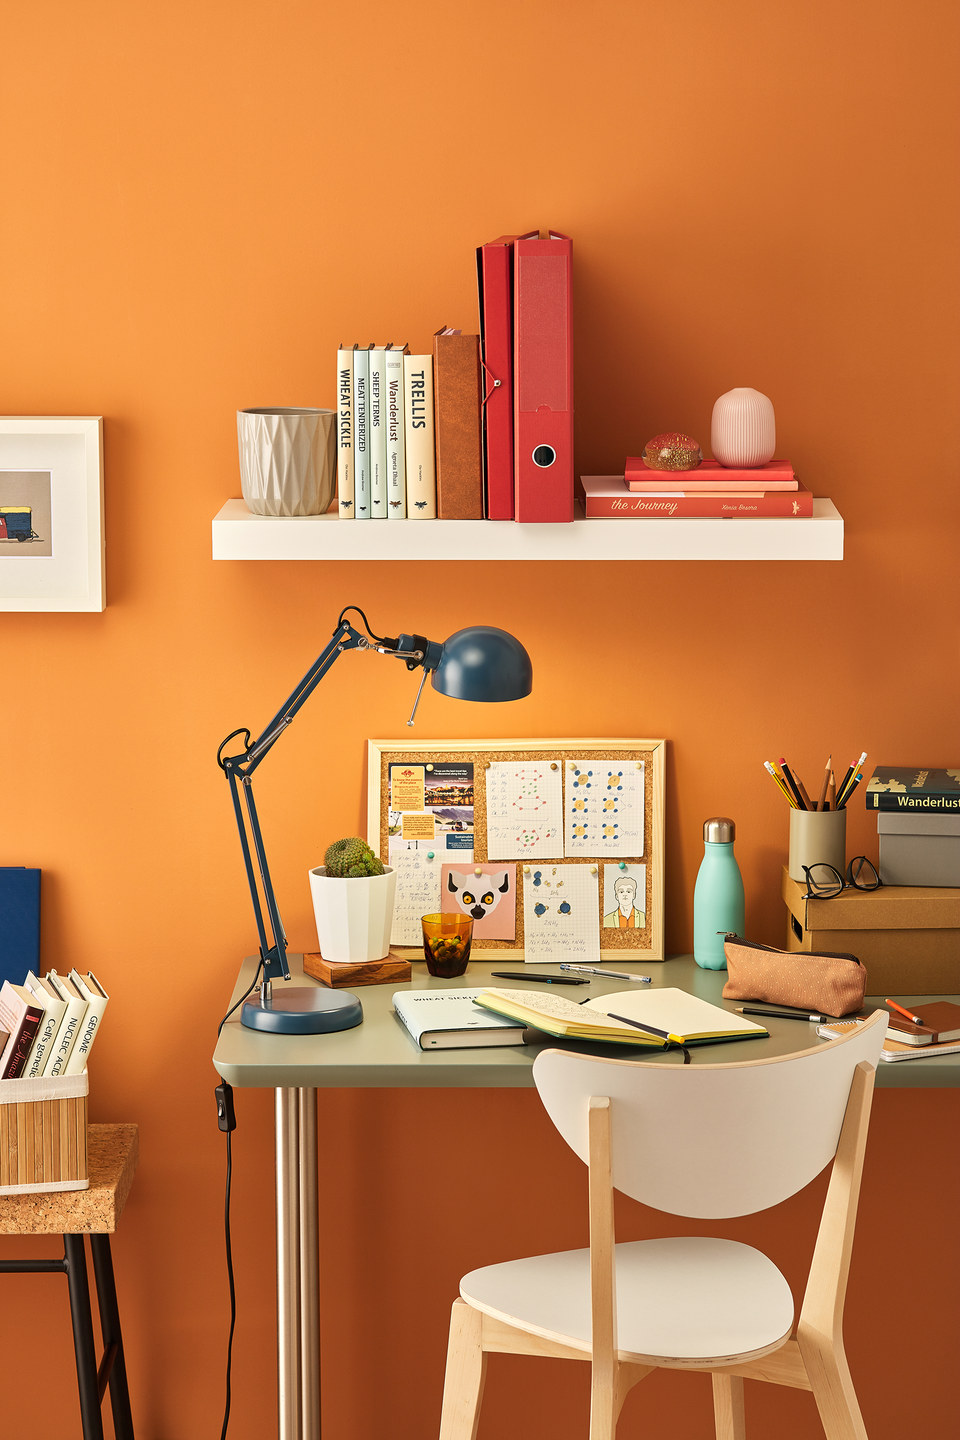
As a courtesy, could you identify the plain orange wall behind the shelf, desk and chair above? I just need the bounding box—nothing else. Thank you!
[0,0,960,1440]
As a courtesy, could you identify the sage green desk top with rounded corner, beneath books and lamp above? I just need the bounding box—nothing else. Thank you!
[213,955,960,1089]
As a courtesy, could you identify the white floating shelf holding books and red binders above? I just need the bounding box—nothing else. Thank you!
[213,500,843,562]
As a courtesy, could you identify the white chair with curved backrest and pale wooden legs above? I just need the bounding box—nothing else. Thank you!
[440,1012,887,1440]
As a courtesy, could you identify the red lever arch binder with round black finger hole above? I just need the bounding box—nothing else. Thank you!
[514,230,574,521]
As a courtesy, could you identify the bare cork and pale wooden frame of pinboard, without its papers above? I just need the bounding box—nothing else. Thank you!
[367,739,666,960]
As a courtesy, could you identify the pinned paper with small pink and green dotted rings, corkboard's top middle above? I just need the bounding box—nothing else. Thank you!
[486,760,563,860]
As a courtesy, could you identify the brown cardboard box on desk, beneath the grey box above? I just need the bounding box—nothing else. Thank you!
[782,865,960,995]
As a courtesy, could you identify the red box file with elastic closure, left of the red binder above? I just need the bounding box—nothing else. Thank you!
[476,230,540,520]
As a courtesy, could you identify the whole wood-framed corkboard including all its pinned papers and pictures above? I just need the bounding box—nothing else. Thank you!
[367,737,666,963]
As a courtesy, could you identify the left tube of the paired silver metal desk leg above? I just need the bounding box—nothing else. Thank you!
[276,1086,304,1440]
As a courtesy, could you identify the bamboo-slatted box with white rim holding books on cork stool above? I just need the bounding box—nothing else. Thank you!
[0,1070,89,1195]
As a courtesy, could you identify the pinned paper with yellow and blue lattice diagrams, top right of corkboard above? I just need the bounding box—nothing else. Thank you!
[563,759,645,858]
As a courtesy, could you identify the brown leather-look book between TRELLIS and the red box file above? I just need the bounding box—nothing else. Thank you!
[433,328,484,520]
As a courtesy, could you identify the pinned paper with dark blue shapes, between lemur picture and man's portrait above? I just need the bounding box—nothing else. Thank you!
[522,864,600,965]
